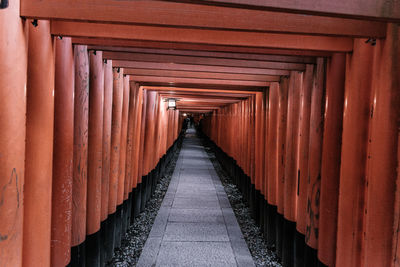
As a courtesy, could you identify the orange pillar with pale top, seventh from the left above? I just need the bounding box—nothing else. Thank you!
[108,68,123,214]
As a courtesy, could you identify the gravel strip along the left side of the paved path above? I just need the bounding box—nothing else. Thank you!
[107,149,179,267]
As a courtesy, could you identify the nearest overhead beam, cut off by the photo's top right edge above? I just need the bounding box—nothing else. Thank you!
[166,0,400,21]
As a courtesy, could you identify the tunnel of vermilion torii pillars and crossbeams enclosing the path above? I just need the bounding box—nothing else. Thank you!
[0,0,400,267]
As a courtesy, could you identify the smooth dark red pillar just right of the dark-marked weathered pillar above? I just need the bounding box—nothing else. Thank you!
[318,54,346,266]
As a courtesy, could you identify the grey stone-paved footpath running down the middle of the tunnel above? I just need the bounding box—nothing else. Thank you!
[137,129,254,266]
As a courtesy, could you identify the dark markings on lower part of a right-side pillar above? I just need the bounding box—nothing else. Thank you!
[305,174,321,243]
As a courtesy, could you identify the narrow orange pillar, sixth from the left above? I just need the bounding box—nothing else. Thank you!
[101,60,113,221]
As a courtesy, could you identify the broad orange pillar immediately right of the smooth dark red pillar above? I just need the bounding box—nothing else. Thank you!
[336,39,375,267]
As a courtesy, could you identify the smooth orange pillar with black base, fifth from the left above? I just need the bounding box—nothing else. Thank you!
[86,51,104,266]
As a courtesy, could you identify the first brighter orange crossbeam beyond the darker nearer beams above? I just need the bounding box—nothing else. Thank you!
[124,69,280,82]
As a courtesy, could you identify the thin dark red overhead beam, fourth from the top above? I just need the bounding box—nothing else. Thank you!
[72,37,331,57]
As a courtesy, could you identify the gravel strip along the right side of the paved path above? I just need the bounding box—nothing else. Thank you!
[203,142,282,267]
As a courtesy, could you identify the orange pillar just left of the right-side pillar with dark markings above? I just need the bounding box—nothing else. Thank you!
[296,65,314,235]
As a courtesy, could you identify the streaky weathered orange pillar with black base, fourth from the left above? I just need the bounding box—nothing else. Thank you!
[71,45,89,266]
